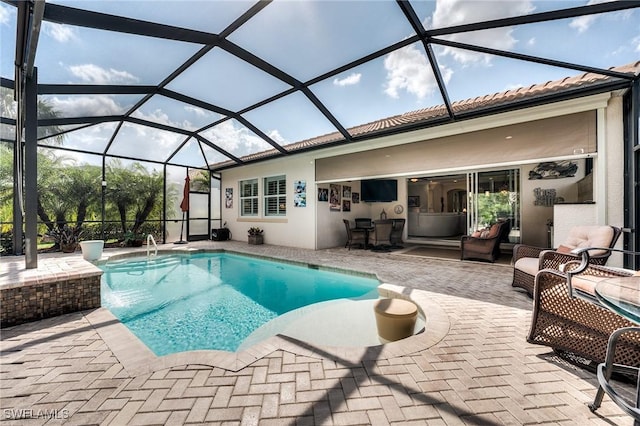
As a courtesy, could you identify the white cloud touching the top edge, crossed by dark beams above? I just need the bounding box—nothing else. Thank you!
[425,0,534,65]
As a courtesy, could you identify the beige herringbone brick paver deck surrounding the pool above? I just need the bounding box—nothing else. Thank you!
[0,241,633,425]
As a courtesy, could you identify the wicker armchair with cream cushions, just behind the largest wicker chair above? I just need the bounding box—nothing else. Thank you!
[511,225,621,296]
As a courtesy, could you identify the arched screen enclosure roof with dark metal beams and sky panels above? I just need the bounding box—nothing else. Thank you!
[0,0,640,170]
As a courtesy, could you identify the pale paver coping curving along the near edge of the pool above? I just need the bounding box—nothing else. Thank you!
[84,283,450,376]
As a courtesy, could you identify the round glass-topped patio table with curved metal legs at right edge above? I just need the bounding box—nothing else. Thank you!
[589,276,640,426]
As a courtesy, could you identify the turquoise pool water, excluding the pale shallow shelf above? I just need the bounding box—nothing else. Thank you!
[101,253,379,355]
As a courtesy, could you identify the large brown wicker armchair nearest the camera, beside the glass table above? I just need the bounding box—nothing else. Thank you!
[527,262,640,370]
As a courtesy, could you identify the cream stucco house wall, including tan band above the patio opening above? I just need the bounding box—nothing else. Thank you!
[221,94,624,249]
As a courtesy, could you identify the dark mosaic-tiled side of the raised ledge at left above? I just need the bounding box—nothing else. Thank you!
[0,273,102,327]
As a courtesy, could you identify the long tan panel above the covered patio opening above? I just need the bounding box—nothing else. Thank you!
[317,111,596,180]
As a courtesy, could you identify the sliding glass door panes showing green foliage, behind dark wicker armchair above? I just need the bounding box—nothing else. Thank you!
[467,169,520,243]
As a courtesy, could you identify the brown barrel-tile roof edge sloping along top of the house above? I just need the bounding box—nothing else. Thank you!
[211,61,640,168]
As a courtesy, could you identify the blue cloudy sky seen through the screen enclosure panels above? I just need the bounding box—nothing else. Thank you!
[0,0,640,170]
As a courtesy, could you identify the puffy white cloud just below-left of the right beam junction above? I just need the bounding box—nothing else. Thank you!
[384,46,452,99]
